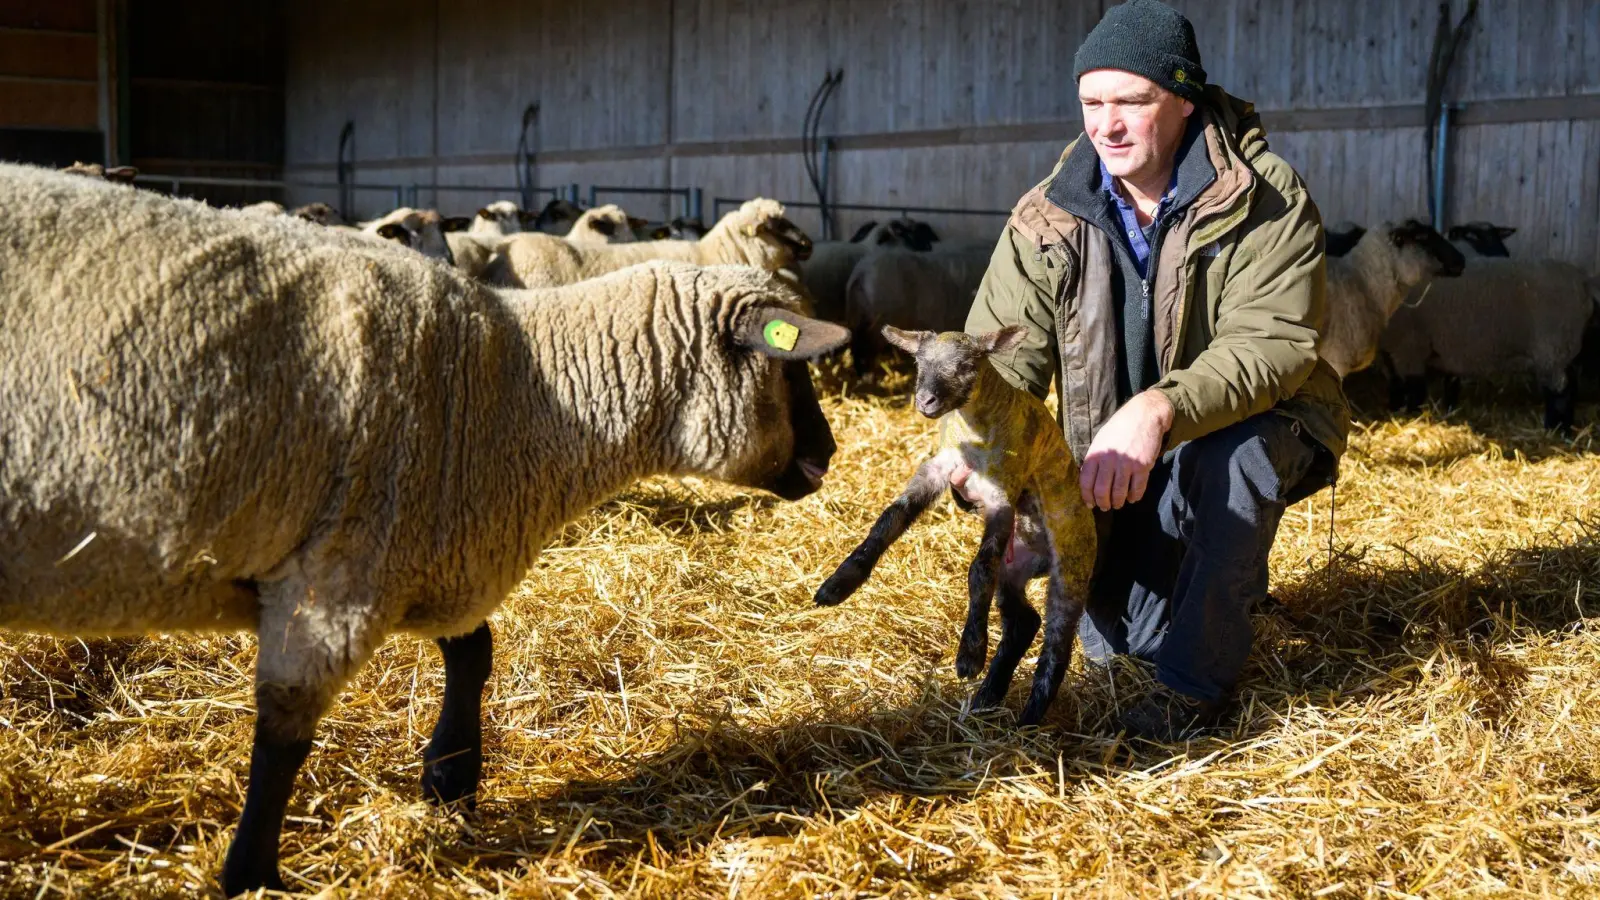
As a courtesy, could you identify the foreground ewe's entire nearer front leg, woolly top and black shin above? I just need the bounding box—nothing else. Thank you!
[222,578,382,897]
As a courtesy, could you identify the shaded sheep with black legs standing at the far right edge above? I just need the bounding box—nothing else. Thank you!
[1381,256,1600,431]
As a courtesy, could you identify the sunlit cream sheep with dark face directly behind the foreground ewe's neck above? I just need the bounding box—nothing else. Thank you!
[485,199,811,288]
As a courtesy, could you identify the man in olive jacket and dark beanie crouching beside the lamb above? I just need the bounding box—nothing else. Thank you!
[952,0,1349,740]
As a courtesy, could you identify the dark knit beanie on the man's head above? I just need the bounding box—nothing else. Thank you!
[1072,0,1205,101]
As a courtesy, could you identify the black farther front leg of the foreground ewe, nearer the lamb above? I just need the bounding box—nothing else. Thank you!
[422,623,494,809]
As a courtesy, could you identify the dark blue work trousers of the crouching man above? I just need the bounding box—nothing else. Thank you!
[1078,413,1333,700]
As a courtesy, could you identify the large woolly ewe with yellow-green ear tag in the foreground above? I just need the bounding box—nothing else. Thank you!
[0,165,848,895]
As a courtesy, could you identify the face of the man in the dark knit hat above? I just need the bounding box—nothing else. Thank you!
[1078,69,1195,183]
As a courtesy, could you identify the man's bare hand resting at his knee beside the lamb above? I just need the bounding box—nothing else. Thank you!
[1078,389,1173,509]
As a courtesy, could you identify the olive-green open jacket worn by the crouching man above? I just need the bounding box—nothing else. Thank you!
[966,86,1350,477]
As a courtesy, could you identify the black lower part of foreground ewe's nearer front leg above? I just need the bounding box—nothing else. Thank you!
[222,684,320,897]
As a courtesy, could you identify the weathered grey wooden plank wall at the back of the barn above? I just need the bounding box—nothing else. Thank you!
[286,0,1600,267]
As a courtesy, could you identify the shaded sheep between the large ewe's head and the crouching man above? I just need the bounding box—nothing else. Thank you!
[845,242,994,375]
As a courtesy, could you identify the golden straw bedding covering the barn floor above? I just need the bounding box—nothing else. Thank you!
[0,361,1600,900]
